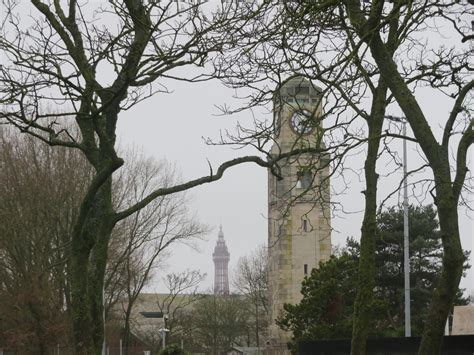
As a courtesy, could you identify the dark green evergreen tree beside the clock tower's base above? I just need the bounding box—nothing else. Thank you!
[278,205,470,340]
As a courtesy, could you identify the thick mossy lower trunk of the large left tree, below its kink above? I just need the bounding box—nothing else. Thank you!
[70,178,113,355]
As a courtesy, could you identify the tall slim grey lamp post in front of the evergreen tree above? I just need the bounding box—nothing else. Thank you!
[385,116,411,337]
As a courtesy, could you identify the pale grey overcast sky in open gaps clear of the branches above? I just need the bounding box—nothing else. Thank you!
[115,75,474,298]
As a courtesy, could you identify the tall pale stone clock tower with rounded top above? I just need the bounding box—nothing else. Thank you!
[267,76,331,354]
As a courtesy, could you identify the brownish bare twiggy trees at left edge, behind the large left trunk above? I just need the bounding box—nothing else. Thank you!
[0,128,89,354]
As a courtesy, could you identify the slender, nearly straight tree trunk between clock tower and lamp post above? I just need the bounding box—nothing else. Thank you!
[351,81,387,355]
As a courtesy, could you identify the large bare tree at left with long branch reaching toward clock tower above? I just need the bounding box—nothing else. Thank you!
[0,0,282,354]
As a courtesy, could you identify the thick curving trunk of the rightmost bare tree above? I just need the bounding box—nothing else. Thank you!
[364,35,464,355]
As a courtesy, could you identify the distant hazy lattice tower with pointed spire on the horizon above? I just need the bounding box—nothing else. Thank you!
[212,225,230,295]
